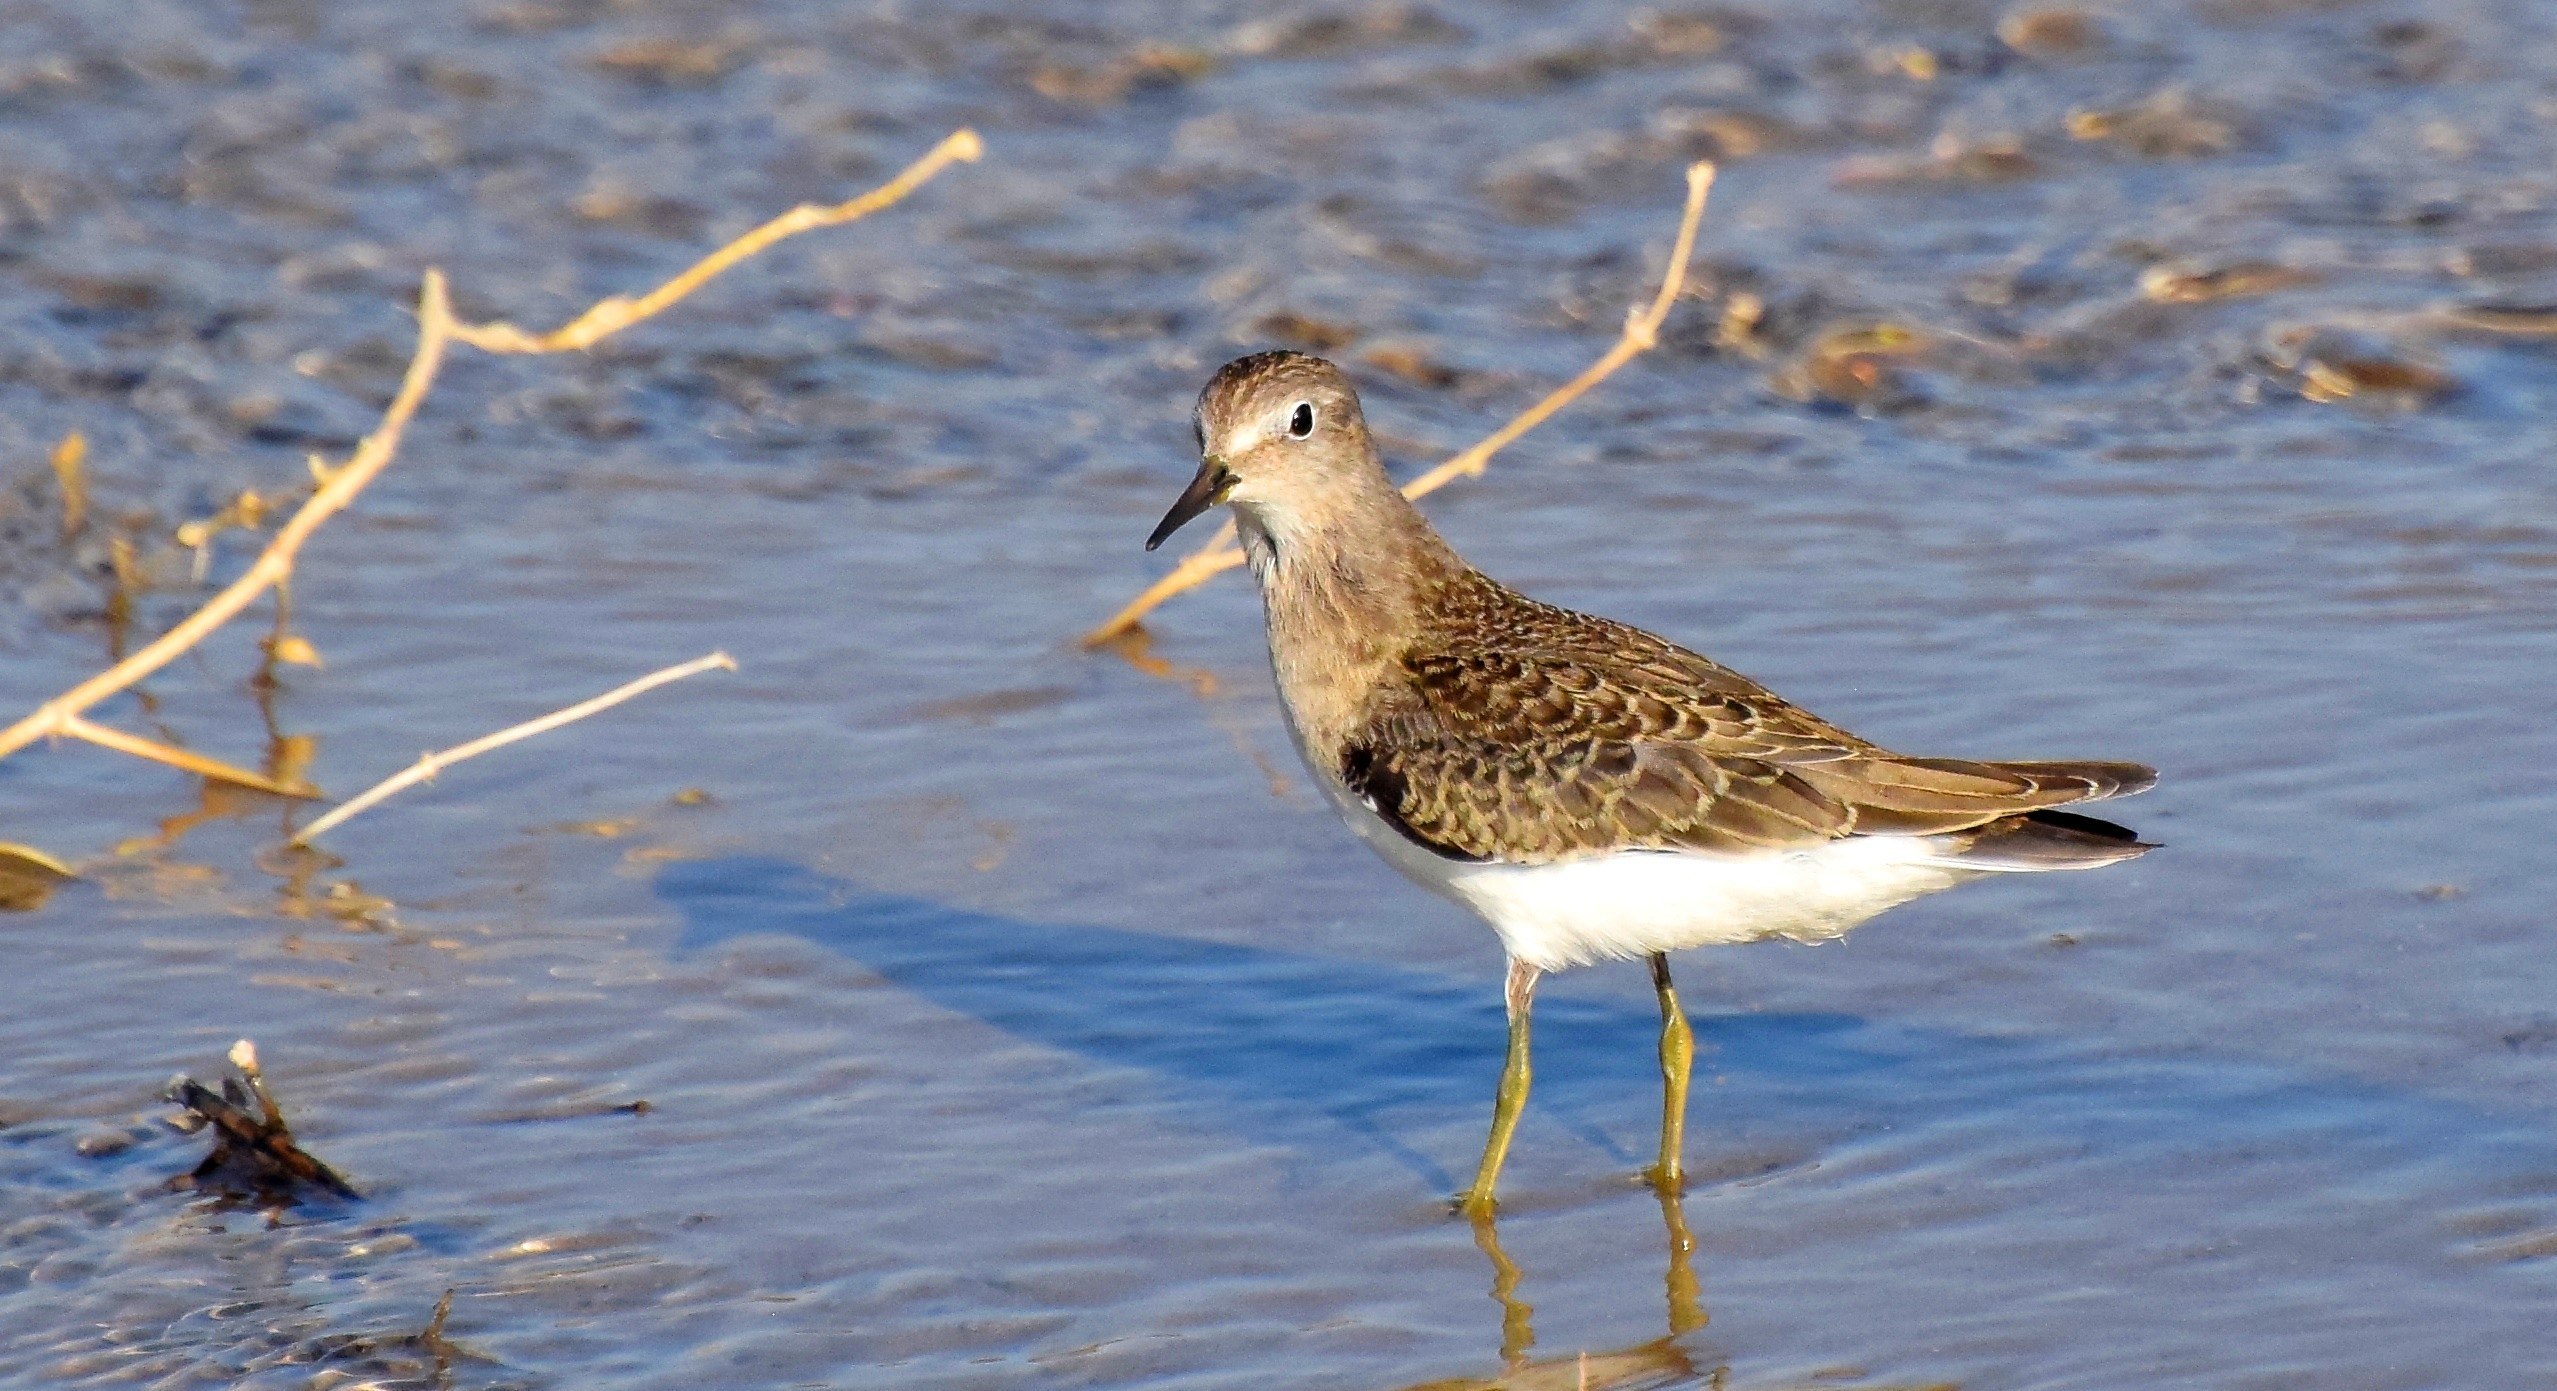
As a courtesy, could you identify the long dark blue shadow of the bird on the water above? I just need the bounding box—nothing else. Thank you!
[657,857,2544,1192]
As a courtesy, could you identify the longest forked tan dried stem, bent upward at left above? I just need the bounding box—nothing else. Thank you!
[0,130,984,797]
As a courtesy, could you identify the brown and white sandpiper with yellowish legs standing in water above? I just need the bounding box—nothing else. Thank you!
[1146,353,2156,1217]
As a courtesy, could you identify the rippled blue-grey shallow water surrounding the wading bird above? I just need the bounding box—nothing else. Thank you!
[0,0,2557,1388]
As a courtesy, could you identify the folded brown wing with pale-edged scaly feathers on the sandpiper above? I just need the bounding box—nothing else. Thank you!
[1342,621,2153,864]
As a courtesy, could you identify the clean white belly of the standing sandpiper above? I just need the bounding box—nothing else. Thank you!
[1319,756,1979,972]
